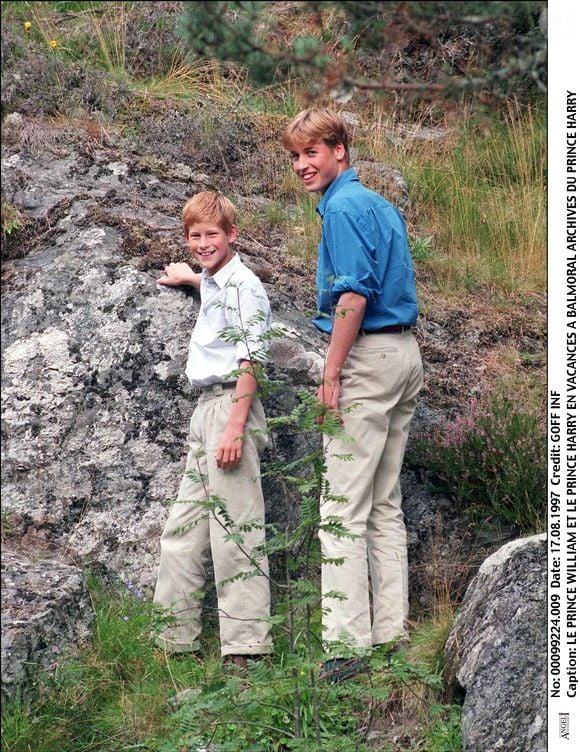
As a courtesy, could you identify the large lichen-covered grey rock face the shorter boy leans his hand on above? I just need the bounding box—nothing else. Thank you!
[2,140,322,587]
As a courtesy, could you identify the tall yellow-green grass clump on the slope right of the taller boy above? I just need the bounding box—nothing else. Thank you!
[401,104,546,292]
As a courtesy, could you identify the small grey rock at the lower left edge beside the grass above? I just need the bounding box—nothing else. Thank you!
[2,552,93,700]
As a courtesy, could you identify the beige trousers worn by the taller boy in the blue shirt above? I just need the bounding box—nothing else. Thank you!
[319,331,423,649]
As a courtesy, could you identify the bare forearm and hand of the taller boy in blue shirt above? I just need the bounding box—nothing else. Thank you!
[316,292,367,420]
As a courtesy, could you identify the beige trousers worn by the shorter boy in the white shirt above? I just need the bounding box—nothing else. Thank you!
[154,388,271,655]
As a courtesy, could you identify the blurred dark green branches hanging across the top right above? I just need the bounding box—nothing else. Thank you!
[184,0,546,106]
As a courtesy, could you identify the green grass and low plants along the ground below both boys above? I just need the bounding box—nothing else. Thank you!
[2,579,462,752]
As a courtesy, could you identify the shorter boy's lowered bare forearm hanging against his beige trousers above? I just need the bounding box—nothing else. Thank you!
[216,360,260,470]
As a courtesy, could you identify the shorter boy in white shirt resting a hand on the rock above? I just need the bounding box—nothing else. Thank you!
[154,191,271,667]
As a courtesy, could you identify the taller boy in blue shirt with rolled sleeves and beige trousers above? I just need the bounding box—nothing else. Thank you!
[282,108,423,681]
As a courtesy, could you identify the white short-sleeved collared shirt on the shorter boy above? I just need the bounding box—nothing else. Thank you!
[185,253,272,386]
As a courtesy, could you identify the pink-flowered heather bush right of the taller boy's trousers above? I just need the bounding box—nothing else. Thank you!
[409,395,546,533]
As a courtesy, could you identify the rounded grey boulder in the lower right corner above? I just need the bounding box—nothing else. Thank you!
[445,535,547,752]
